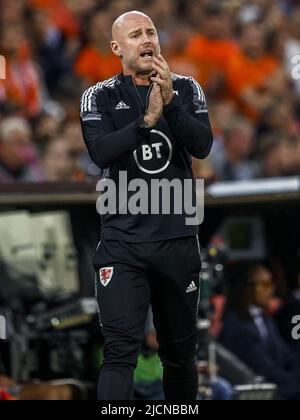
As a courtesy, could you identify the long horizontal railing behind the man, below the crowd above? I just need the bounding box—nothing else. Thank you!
[0,178,300,209]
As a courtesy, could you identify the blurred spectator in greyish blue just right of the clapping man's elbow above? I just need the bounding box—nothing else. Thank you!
[212,120,256,181]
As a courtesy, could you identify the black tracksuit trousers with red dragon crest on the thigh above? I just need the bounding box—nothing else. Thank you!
[95,236,201,400]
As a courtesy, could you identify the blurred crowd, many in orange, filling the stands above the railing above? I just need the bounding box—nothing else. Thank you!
[0,0,300,184]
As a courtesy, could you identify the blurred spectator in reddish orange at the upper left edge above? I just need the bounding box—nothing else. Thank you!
[0,24,42,118]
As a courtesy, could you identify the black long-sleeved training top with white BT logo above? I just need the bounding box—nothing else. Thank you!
[80,74,213,242]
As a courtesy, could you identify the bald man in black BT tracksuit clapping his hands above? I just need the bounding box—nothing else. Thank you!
[81,12,212,400]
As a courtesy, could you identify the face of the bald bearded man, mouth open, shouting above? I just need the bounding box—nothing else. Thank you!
[112,15,160,75]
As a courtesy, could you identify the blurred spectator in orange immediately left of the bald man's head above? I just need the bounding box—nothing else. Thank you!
[75,12,122,84]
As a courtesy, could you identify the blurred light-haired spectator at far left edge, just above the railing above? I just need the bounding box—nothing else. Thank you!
[0,117,42,184]
